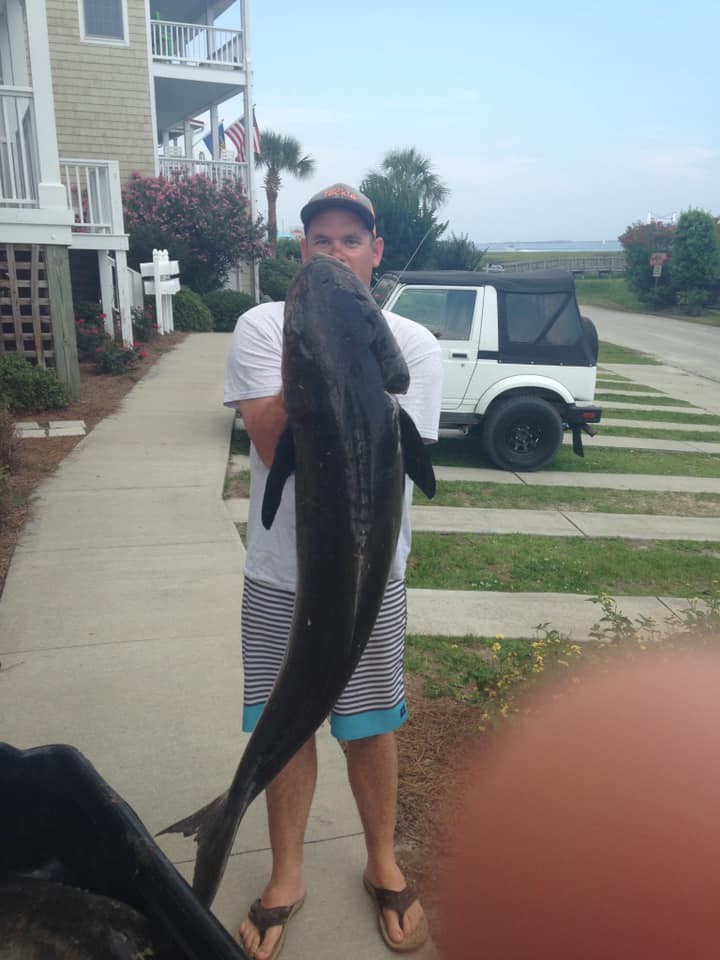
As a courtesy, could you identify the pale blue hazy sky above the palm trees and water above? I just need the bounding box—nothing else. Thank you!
[220,0,720,243]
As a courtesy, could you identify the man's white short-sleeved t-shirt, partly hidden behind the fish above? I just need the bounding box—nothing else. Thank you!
[225,302,442,591]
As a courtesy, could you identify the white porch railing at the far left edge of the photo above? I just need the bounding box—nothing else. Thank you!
[0,86,38,207]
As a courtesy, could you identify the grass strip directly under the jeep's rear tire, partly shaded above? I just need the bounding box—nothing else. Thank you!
[432,438,720,477]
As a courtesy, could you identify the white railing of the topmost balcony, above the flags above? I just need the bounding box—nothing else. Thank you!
[150,20,244,68]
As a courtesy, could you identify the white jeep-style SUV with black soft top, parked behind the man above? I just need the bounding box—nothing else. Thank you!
[373,270,601,471]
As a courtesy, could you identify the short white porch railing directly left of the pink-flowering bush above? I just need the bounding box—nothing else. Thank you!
[60,158,124,234]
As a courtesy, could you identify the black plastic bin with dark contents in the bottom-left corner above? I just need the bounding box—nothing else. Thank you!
[0,743,247,960]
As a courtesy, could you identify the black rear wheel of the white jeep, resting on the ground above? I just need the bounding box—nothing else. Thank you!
[483,397,563,470]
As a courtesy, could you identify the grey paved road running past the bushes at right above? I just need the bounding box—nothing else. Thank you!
[582,306,720,383]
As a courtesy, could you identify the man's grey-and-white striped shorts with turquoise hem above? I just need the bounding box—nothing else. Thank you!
[242,577,407,740]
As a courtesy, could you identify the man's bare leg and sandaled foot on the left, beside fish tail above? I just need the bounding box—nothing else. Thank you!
[238,737,317,960]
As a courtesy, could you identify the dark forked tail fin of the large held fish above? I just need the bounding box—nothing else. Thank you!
[158,792,239,907]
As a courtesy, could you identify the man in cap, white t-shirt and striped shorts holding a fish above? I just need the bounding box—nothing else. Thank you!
[225,184,442,960]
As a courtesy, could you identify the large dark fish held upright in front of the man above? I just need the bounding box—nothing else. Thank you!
[163,256,435,904]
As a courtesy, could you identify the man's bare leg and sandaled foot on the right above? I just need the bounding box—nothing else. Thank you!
[346,733,423,943]
